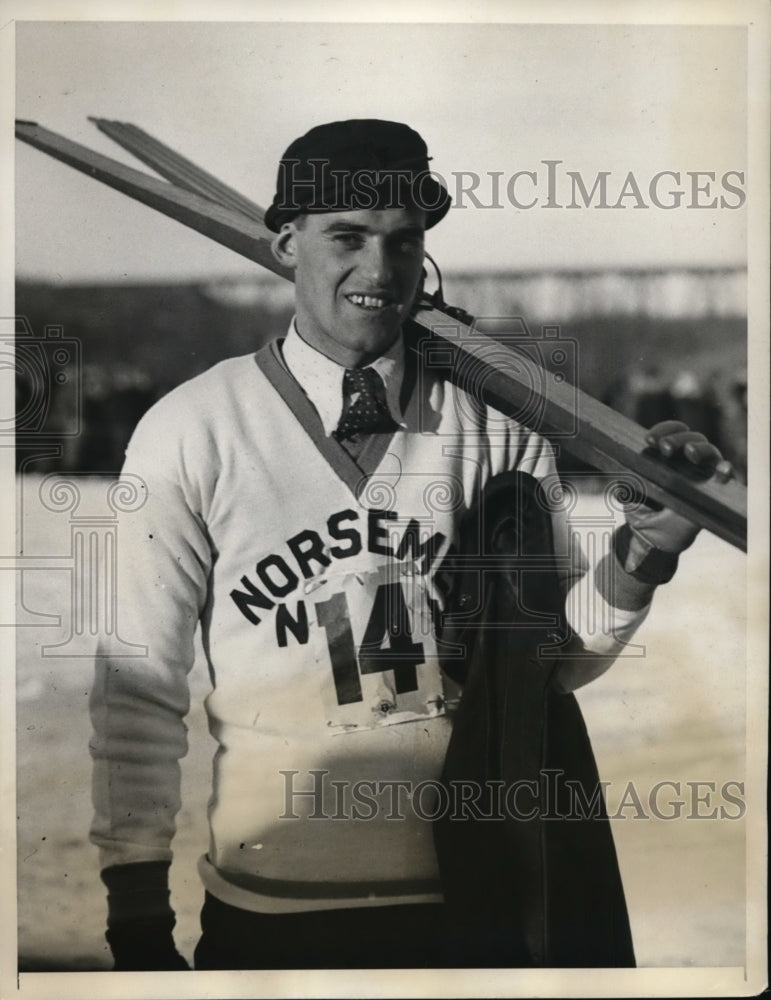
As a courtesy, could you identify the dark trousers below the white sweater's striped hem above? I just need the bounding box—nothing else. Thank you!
[195,893,522,969]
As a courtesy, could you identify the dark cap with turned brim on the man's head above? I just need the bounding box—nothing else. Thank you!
[265,118,450,233]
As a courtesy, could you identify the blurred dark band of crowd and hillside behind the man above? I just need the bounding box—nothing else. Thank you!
[16,270,747,482]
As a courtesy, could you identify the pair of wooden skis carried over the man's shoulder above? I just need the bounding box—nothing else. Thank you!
[16,119,747,551]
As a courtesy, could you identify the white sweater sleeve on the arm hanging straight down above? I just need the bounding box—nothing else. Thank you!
[90,408,212,869]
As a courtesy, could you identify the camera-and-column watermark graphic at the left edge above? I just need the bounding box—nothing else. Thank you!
[0,316,147,658]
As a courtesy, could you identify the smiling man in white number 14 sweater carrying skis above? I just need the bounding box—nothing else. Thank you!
[87,120,722,969]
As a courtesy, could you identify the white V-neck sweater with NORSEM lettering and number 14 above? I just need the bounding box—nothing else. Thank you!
[87,345,647,912]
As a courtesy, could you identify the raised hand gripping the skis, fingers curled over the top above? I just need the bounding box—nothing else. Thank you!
[616,420,733,584]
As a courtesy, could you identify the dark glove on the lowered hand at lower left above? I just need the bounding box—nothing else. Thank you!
[102,861,190,972]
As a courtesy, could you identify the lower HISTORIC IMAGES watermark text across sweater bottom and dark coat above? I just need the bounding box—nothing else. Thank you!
[278,768,746,822]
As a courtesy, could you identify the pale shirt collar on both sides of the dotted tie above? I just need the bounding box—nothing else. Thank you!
[281,319,406,437]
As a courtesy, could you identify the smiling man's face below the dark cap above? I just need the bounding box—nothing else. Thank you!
[276,208,426,368]
